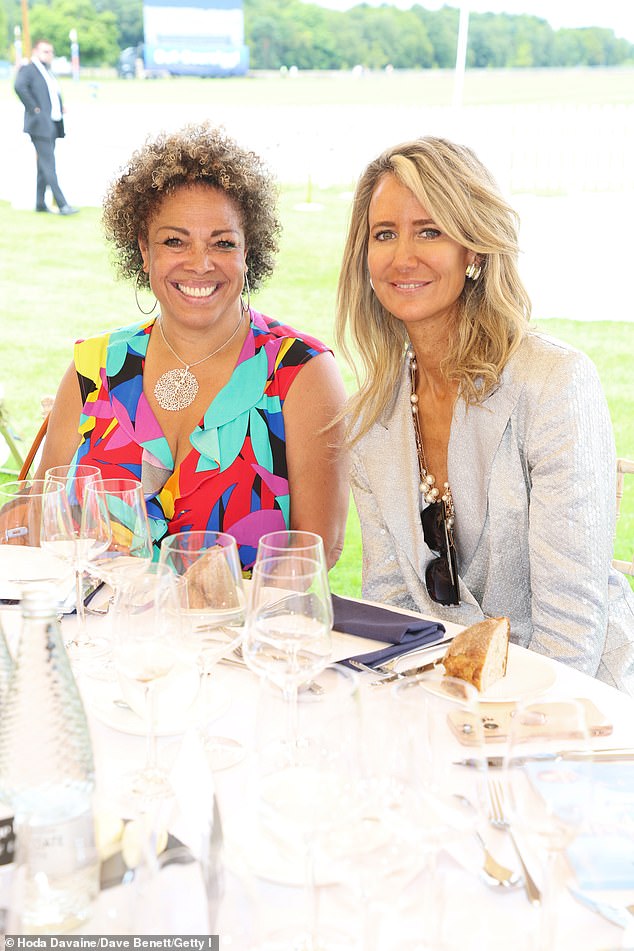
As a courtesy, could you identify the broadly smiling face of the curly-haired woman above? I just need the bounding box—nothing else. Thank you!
[139,185,246,330]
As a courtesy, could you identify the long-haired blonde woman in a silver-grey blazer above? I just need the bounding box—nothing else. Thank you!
[337,137,634,690]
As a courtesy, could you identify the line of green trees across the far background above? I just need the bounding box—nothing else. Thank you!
[0,0,634,70]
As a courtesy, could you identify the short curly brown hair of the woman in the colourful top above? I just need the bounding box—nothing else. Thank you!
[102,123,281,290]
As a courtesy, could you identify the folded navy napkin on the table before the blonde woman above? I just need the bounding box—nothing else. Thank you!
[332,594,445,667]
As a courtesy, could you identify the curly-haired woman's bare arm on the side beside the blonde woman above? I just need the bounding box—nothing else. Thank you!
[283,353,349,568]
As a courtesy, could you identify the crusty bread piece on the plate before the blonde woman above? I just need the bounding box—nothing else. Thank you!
[442,617,511,692]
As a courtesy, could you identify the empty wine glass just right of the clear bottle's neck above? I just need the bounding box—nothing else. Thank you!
[111,564,190,798]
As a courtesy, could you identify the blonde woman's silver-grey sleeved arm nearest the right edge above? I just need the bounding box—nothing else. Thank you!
[527,352,615,676]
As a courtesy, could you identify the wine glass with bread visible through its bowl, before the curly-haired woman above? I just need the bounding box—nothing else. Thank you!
[160,531,245,769]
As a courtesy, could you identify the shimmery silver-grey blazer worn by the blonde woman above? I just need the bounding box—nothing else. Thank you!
[352,333,634,693]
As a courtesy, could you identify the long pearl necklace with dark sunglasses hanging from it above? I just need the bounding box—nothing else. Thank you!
[408,350,460,604]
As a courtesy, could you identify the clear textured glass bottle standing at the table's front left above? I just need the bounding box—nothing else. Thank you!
[0,590,99,934]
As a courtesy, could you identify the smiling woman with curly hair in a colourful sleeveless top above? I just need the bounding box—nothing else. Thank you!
[39,125,348,570]
